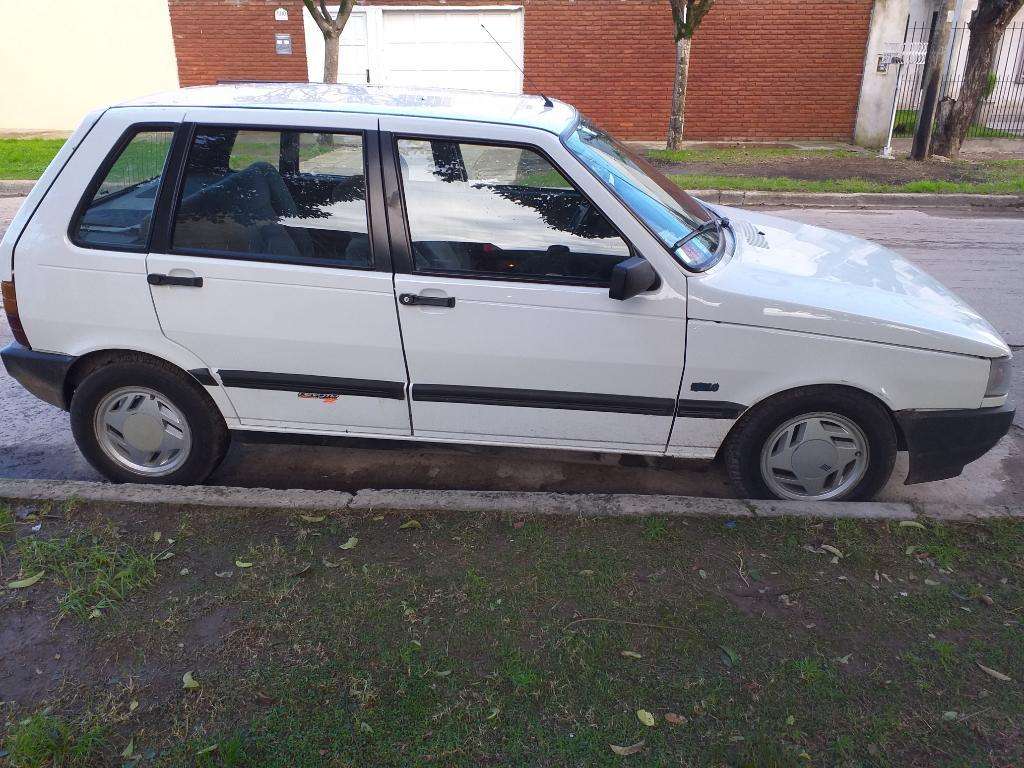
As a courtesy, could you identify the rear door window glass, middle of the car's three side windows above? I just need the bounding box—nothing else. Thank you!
[172,127,373,268]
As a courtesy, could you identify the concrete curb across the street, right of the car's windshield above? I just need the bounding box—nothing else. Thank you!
[688,189,1024,209]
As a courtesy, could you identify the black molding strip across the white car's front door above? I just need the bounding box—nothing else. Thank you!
[413,384,675,416]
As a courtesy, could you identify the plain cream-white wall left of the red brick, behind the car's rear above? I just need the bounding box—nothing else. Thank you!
[0,0,178,131]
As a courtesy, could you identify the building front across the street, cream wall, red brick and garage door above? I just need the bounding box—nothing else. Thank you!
[0,0,883,141]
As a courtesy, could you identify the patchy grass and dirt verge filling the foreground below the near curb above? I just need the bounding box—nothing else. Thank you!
[0,505,1024,768]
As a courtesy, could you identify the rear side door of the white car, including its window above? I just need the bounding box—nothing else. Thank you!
[147,110,411,435]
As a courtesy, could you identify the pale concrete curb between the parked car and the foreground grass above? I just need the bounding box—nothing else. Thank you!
[0,479,1024,521]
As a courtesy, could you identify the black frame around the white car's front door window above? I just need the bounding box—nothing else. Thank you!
[381,131,638,289]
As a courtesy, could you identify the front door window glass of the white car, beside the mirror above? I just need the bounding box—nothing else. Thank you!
[398,138,631,286]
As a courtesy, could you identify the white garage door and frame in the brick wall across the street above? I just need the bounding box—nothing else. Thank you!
[303,6,523,93]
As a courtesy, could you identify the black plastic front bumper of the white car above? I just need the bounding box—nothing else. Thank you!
[895,403,1015,485]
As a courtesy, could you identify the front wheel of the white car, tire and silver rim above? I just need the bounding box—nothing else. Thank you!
[723,387,897,501]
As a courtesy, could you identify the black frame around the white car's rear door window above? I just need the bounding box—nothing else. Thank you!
[160,122,392,272]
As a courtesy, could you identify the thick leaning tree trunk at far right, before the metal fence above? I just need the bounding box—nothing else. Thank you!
[933,0,1024,158]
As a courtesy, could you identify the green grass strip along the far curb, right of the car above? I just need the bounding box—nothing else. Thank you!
[669,171,1024,195]
